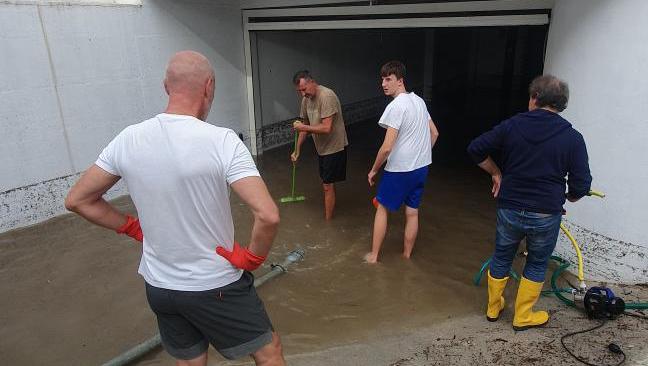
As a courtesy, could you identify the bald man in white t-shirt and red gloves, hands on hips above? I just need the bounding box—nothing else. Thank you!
[65,51,284,366]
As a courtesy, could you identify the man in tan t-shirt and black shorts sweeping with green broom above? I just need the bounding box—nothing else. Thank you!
[290,70,349,220]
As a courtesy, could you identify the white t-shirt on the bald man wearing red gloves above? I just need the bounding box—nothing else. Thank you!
[95,113,259,291]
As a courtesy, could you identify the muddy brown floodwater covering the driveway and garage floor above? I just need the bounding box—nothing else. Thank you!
[0,123,495,365]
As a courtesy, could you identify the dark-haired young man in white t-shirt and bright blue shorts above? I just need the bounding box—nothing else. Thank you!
[365,61,439,263]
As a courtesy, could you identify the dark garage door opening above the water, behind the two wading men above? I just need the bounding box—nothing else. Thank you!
[251,25,547,165]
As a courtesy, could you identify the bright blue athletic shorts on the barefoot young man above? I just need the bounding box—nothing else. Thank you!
[376,166,428,211]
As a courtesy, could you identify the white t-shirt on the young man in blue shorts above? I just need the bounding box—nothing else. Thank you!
[378,93,432,172]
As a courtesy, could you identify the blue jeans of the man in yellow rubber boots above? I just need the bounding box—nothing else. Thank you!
[490,208,562,282]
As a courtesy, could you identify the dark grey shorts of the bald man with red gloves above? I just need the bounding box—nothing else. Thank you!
[146,272,272,360]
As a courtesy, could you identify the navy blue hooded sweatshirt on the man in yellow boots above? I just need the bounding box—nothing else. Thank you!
[468,109,592,214]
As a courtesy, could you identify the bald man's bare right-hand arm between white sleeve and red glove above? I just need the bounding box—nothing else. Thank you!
[231,177,279,257]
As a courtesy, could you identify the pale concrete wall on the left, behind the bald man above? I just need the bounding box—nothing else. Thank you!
[0,0,247,232]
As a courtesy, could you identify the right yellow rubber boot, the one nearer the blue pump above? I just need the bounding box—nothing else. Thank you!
[513,277,549,330]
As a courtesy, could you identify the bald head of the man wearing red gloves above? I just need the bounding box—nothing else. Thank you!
[164,51,214,95]
